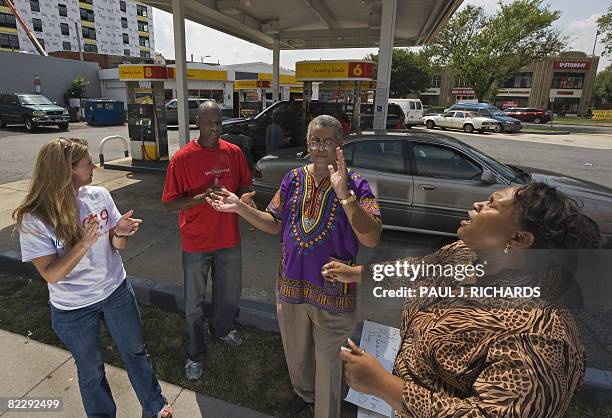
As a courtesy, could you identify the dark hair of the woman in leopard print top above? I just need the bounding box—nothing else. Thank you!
[514,182,601,249]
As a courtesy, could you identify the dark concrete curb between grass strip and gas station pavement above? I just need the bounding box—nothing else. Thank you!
[0,251,612,404]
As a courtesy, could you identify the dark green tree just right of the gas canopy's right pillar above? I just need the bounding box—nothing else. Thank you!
[365,48,432,98]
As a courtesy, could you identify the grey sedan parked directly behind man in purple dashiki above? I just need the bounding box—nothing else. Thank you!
[253,131,612,246]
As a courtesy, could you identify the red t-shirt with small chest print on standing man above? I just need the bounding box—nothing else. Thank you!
[162,139,251,252]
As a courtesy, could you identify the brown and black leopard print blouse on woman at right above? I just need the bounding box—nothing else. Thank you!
[370,241,585,418]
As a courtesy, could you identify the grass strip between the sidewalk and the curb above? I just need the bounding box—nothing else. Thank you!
[0,274,612,418]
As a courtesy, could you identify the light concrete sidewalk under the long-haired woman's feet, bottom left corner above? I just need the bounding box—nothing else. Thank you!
[0,330,272,418]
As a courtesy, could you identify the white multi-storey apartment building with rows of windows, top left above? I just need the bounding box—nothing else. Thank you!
[0,0,155,58]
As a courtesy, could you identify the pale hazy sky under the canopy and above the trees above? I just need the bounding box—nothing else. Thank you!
[153,0,611,70]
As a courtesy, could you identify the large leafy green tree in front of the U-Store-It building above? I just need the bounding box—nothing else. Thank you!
[426,0,567,101]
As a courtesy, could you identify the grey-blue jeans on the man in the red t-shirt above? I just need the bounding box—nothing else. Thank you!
[183,245,242,362]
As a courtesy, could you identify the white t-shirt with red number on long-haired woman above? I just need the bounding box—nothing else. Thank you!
[19,186,126,310]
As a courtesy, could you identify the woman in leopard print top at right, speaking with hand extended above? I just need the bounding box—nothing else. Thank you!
[323,183,600,418]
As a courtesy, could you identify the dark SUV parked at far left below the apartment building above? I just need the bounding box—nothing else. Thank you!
[0,93,70,132]
